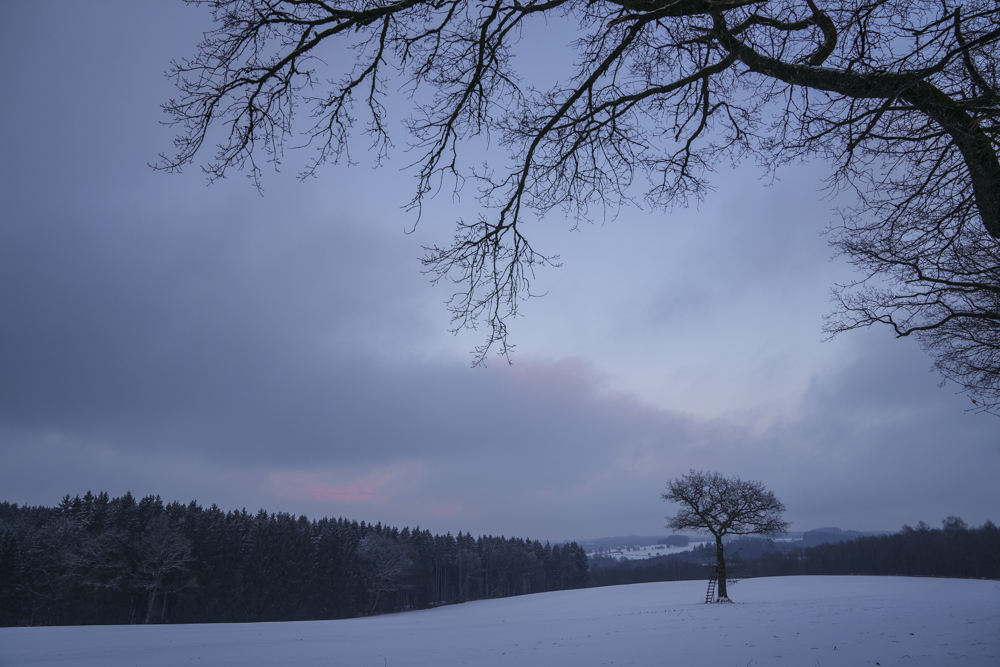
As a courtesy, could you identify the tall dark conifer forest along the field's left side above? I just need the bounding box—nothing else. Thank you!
[0,492,588,626]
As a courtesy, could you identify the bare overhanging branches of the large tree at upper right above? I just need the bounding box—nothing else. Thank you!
[159,0,1000,409]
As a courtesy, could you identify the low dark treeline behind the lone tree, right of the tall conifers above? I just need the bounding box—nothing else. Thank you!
[590,517,1000,586]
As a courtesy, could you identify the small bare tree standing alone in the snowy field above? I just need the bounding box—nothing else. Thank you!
[662,470,789,601]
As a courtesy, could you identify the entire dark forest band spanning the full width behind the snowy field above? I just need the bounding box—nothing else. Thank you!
[0,492,1000,626]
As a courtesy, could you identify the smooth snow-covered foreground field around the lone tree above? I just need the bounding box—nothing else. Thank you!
[0,577,1000,667]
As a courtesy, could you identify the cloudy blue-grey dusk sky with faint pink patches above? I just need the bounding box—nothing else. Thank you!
[0,0,1000,540]
